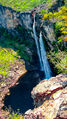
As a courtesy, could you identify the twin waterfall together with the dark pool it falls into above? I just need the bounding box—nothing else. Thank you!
[4,11,51,114]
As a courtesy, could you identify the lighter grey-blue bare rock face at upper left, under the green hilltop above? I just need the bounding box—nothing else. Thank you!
[0,5,32,30]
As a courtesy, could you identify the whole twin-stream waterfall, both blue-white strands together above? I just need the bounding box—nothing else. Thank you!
[33,15,51,79]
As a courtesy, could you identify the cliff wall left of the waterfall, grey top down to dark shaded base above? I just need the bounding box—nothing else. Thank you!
[0,5,38,70]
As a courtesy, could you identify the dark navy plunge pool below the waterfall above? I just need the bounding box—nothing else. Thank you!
[4,71,42,113]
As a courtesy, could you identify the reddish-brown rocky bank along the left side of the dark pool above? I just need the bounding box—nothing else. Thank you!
[0,61,27,119]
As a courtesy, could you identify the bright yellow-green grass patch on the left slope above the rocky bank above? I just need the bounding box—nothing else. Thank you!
[0,47,17,76]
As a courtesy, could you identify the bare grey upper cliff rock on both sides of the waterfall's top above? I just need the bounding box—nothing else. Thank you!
[0,0,64,48]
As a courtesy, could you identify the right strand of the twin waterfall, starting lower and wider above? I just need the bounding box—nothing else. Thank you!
[39,32,51,79]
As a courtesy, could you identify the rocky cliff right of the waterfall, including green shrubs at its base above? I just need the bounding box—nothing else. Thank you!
[35,0,67,75]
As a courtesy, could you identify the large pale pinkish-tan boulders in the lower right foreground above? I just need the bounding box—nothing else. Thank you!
[24,74,67,119]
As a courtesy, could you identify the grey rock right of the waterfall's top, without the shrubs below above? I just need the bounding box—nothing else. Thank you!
[35,0,65,50]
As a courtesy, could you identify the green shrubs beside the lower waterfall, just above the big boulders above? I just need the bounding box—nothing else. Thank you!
[47,51,67,74]
